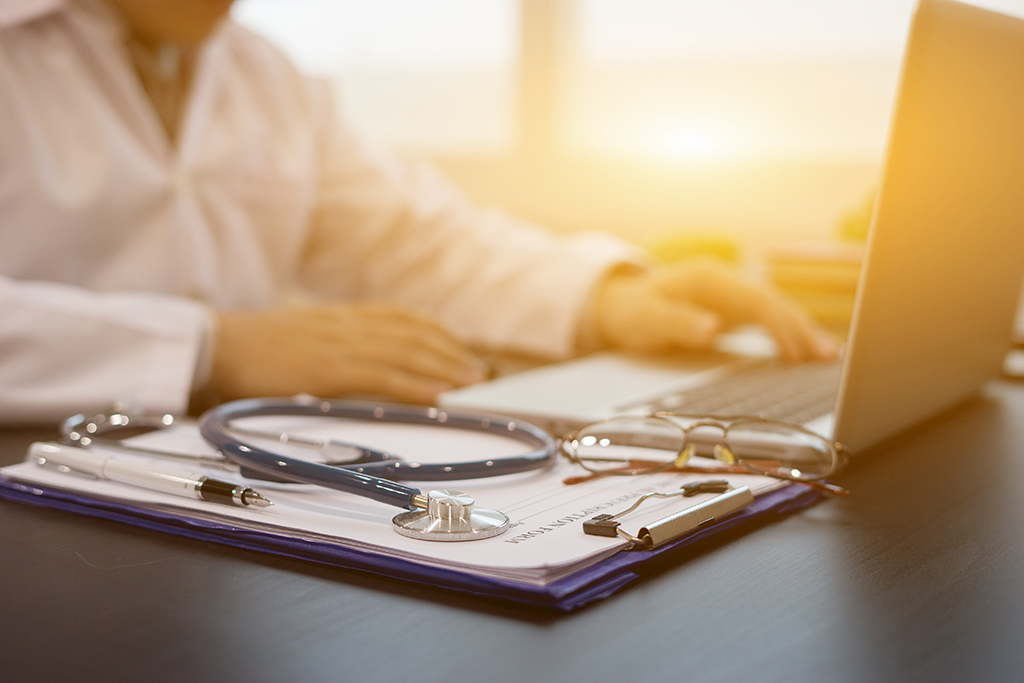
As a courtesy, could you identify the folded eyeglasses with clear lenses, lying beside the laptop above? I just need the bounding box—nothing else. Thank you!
[561,413,849,496]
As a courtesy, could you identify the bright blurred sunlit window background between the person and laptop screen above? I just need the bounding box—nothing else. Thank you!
[233,0,1024,325]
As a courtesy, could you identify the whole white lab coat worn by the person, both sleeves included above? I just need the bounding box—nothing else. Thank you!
[0,0,633,423]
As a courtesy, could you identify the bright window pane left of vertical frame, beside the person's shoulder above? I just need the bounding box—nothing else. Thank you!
[232,0,519,154]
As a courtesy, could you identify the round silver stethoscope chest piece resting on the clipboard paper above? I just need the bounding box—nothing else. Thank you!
[391,488,509,541]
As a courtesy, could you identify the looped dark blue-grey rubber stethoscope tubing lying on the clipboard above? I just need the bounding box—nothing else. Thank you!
[199,398,556,510]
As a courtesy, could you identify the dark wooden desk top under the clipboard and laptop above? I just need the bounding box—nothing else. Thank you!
[0,384,1024,683]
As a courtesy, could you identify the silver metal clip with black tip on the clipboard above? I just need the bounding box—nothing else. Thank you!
[583,479,754,550]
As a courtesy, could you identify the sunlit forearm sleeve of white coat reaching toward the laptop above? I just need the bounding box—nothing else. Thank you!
[303,98,641,358]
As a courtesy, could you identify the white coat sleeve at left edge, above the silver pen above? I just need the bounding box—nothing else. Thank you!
[0,278,210,424]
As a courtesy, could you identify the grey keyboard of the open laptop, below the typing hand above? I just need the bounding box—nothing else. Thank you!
[620,361,840,424]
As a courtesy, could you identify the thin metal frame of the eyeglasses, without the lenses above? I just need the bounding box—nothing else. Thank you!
[558,411,850,496]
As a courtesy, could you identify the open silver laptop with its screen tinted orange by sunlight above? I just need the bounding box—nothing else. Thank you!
[440,0,1024,454]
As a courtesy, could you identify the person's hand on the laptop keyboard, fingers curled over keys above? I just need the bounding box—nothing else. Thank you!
[593,260,839,360]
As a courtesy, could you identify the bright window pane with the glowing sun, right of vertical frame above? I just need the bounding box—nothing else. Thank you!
[562,0,912,162]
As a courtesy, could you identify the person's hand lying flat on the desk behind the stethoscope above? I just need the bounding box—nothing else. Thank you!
[208,305,487,403]
